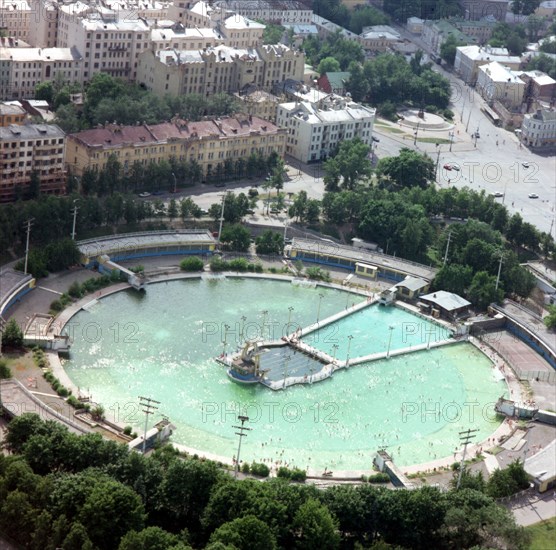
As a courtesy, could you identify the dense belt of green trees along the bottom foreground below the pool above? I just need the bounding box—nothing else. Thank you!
[0,414,528,550]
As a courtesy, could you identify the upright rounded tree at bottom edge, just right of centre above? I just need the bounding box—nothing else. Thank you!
[293,499,340,550]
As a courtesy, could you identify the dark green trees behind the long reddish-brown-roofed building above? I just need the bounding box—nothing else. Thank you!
[50,73,241,133]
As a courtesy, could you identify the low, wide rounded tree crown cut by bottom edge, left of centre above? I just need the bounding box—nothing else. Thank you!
[210,515,276,550]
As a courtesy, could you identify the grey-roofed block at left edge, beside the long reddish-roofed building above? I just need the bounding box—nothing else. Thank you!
[0,124,66,202]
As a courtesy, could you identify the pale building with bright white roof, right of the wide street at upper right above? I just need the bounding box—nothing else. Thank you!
[477,61,526,111]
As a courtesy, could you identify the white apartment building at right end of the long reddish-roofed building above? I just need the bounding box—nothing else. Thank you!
[276,94,376,162]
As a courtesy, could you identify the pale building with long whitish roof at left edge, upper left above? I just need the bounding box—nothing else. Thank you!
[0,48,83,99]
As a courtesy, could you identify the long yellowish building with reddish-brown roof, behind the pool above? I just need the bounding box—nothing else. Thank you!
[66,115,286,178]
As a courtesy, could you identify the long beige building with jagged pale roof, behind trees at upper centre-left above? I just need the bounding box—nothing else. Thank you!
[137,44,304,95]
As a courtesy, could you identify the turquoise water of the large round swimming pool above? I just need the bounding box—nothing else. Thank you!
[65,278,506,470]
